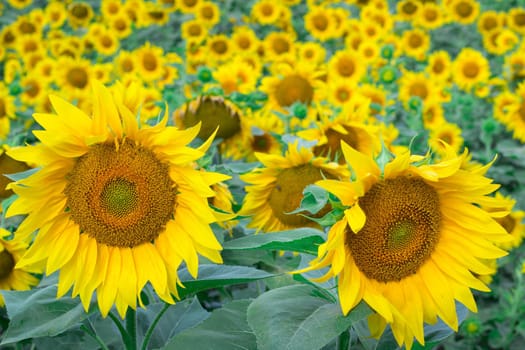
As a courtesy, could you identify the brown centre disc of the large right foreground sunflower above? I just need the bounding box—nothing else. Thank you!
[346,177,441,282]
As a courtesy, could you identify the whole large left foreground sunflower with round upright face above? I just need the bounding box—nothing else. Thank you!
[6,82,228,317]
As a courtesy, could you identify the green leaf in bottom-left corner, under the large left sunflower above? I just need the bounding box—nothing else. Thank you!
[1,285,97,345]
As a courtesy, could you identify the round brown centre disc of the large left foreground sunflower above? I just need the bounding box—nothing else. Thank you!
[64,141,177,247]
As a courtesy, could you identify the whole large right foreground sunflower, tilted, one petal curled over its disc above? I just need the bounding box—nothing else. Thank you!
[299,144,508,349]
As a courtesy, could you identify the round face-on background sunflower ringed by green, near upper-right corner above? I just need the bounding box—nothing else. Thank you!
[452,48,490,91]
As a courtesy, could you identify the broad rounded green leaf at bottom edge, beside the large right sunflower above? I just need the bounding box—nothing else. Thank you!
[248,285,371,350]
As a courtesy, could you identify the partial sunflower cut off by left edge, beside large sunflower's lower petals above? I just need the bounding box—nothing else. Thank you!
[0,228,39,306]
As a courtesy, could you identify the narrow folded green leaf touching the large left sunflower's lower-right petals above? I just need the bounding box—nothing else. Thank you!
[179,265,274,298]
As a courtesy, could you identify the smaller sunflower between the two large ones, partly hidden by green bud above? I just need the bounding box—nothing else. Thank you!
[238,143,348,232]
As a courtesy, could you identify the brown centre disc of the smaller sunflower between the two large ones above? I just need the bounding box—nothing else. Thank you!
[268,164,332,227]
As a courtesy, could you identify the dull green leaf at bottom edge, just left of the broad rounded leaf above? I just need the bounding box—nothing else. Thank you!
[164,300,257,350]
